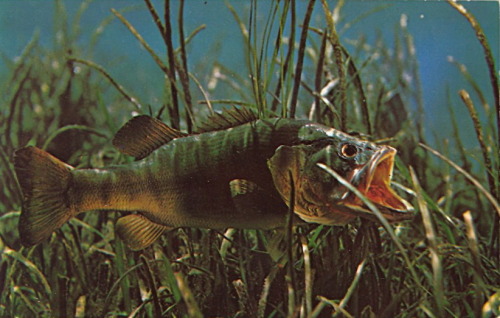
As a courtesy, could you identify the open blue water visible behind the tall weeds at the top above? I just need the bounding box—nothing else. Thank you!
[0,0,499,154]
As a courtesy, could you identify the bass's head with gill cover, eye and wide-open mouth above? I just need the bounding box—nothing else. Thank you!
[268,124,412,225]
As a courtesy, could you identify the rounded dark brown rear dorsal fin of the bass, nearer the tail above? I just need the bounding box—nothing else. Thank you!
[113,115,186,159]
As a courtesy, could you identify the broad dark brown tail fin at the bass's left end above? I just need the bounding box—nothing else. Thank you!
[14,146,74,246]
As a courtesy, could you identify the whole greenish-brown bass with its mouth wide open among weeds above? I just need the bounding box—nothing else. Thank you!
[14,107,412,250]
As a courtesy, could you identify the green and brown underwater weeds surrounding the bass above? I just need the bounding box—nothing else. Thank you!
[0,0,500,317]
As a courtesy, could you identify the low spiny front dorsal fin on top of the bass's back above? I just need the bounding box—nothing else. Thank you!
[197,107,259,133]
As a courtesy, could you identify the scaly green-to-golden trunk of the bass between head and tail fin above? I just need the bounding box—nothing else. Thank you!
[70,120,291,228]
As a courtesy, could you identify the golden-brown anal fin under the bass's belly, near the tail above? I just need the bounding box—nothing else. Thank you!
[116,214,171,251]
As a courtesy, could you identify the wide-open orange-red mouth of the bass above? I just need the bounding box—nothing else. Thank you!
[343,146,413,222]
